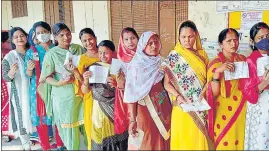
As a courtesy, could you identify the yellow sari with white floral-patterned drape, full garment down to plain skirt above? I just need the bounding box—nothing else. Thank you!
[165,33,214,150]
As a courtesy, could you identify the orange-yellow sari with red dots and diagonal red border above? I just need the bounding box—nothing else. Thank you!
[207,52,246,150]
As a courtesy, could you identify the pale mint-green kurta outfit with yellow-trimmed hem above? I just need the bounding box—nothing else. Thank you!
[38,44,84,150]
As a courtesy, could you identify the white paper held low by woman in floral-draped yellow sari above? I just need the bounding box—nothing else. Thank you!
[180,98,211,112]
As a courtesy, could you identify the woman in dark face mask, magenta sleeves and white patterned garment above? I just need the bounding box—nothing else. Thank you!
[242,22,269,150]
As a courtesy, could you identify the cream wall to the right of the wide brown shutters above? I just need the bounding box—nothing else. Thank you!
[188,1,251,59]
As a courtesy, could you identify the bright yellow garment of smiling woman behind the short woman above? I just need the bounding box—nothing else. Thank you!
[75,54,99,150]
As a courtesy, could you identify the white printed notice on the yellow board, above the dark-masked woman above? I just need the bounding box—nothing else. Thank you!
[240,12,262,30]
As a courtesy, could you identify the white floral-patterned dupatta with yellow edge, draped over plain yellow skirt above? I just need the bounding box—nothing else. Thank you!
[164,28,211,142]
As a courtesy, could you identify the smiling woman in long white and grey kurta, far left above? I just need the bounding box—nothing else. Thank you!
[2,27,33,150]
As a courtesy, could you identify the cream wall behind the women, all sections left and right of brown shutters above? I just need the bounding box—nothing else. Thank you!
[2,1,253,58]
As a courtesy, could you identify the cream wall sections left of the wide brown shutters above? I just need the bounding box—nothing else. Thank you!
[2,1,110,44]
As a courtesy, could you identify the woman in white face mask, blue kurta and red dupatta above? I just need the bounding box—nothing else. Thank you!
[24,21,63,150]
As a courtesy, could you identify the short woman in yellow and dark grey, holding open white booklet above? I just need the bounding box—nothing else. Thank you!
[81,40,128,150]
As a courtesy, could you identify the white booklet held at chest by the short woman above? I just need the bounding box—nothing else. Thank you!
[89,66,108,84]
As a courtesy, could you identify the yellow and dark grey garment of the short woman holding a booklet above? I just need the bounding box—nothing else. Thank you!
[91,62,128,150]
